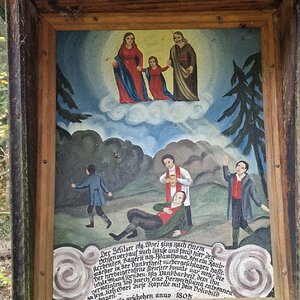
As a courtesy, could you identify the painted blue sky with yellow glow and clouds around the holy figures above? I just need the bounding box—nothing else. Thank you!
[57,29,260,171]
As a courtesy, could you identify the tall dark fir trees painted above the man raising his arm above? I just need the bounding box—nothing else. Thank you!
[218,53,268,197]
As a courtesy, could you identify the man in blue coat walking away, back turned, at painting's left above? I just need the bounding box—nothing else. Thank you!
[71,164,112,228]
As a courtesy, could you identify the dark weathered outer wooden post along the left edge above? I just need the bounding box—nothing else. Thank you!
[6,0,37,299]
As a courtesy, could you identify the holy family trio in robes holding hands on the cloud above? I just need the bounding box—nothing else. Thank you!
[113,31,199,103]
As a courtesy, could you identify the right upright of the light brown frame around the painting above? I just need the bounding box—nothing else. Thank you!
[261,12,294,300]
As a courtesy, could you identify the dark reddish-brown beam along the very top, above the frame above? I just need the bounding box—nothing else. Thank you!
[34,0,278,15]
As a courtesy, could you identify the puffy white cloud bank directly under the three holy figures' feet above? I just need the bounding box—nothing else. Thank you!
[99,93,213,125]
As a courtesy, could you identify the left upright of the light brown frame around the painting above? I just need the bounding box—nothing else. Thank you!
[34,15,56,300]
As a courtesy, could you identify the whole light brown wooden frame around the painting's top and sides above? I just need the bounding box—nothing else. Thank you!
[34,11,293,300]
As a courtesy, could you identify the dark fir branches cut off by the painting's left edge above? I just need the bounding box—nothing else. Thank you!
[56,65,91,123]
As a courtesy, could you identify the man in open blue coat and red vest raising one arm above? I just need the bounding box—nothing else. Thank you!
[223,155,269,249]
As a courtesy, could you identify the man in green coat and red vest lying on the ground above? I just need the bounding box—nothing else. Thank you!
[109,191,188,241]
